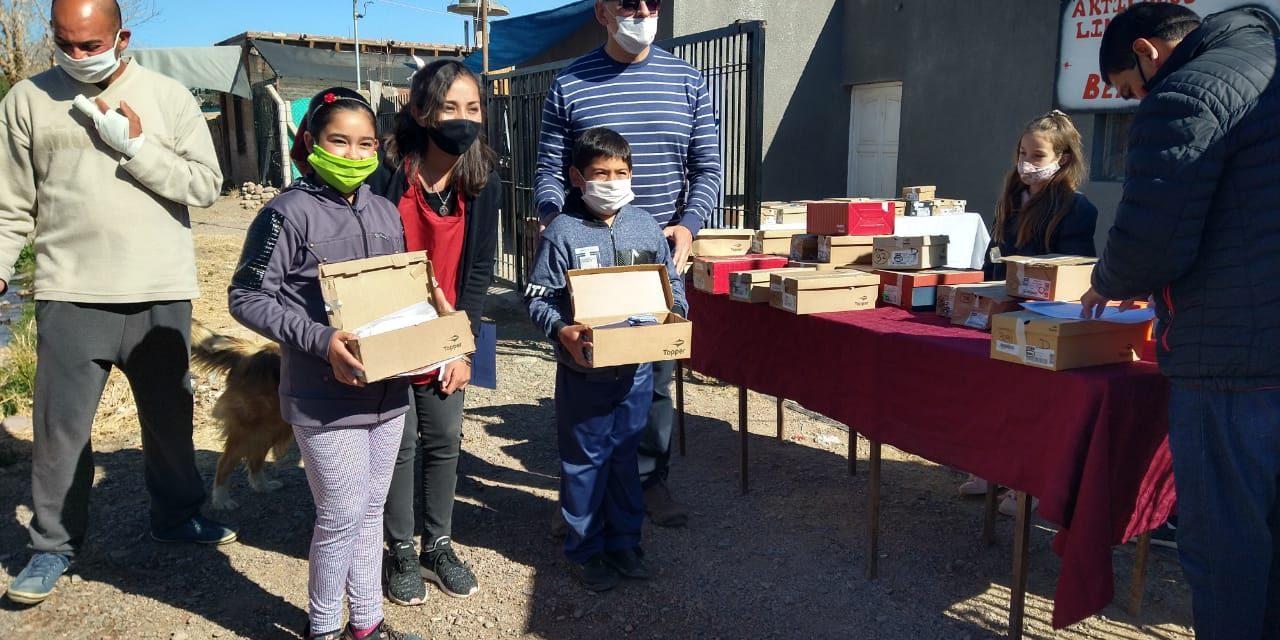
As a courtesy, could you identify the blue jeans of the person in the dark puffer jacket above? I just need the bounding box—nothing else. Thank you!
[1169,384,1280,640]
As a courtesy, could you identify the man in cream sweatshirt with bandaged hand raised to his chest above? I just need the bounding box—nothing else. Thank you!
[0,0,236,604]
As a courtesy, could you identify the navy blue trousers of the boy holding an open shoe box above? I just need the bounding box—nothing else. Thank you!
[556,365,653,564]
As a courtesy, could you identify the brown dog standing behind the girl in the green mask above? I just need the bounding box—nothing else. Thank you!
[191,324,293,509]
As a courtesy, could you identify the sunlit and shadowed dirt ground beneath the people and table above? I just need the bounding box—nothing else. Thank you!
[0,198,1192,640]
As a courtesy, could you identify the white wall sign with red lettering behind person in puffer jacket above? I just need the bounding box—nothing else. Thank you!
[1057,0,1280,111]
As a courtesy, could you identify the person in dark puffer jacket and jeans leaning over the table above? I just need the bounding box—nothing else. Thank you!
[1082,3,1280,639]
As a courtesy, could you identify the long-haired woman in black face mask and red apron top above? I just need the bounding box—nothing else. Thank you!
[367,60,502,605]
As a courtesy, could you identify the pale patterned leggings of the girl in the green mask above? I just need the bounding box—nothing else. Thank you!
[293,416,404,634]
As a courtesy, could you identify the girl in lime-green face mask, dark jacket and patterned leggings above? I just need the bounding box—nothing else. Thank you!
[228,87,419,640]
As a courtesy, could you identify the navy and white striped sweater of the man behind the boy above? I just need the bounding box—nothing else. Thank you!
[534,47,722,236]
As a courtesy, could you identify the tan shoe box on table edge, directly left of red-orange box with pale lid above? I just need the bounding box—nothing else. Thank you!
[769,270,879,315]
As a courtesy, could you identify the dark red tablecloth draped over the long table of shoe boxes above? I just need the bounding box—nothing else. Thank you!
[689,288,1174,628]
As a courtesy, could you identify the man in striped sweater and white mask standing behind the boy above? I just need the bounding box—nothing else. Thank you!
[534,0,722,526]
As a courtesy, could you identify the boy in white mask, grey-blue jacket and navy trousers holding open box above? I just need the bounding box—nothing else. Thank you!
[525,128,687,591]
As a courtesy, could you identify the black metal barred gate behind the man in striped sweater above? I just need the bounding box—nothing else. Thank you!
[485,20,764,287]
